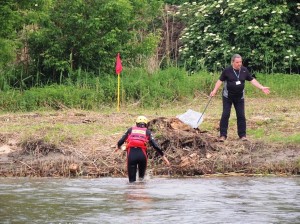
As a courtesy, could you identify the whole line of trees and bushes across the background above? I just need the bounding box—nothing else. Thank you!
[0,0,300,89]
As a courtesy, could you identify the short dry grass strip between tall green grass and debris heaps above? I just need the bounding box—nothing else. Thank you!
[0,97,300,145]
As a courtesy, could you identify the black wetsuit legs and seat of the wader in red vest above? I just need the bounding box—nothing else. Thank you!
[127,147,147,182]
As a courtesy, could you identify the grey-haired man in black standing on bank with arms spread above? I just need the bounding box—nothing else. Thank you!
[210,54,270,142]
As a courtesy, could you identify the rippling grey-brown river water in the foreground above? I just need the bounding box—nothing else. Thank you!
[0,177,300,224]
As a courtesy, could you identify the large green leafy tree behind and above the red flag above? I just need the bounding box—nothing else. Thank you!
[29,0,164,81]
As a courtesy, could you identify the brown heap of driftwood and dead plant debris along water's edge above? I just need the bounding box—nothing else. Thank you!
[0,117,299,177]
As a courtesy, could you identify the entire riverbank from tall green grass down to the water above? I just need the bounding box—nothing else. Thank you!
[0,68,300,177]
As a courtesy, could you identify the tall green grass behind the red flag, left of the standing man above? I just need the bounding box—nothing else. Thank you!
[0,68,213,111]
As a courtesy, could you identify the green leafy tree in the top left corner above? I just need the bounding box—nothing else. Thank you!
[0,0,52,89]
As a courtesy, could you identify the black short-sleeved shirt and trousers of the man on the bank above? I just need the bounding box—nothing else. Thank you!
[220,66,253,138]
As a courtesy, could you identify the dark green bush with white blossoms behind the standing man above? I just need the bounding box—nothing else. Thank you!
[177,0,300,73]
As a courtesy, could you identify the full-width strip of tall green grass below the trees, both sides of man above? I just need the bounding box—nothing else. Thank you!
[0,68,300,111]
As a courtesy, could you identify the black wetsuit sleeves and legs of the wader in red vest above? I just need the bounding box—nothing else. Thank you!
[118,128,164,182]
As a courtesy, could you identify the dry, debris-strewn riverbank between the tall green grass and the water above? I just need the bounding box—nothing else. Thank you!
[0,95,300,177]
